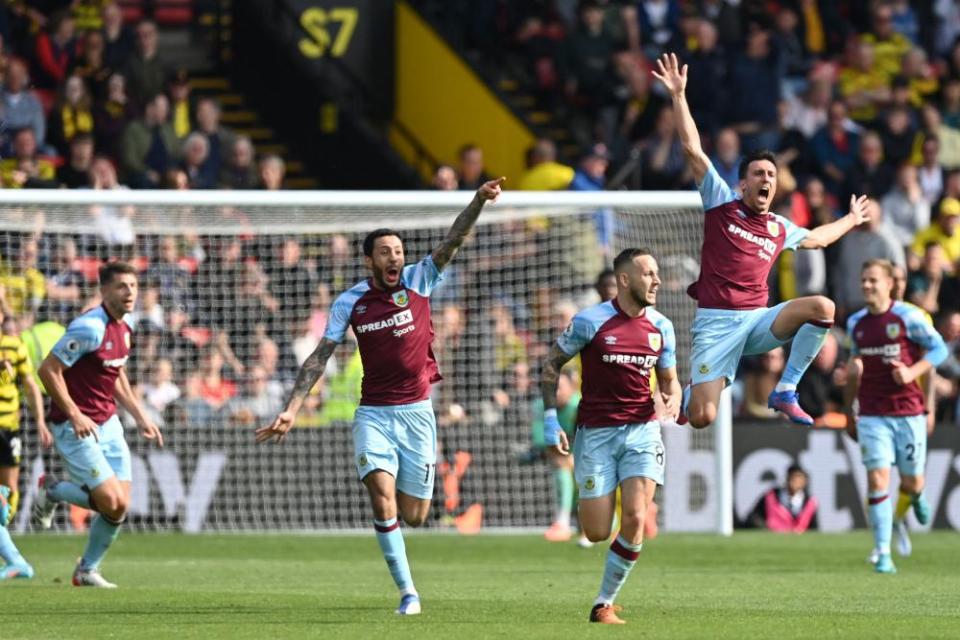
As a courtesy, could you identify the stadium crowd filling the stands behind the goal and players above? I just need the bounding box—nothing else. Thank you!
[0,0,960,448]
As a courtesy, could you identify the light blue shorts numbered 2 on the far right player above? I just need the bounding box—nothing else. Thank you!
[857,415,927,476]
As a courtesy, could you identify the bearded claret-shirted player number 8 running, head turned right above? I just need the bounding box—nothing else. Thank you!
[541,249,681,624]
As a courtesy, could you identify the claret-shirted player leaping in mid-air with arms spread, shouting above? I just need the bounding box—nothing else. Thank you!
[653,54,867,428]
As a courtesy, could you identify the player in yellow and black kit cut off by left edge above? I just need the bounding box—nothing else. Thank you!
[0,304,53,580]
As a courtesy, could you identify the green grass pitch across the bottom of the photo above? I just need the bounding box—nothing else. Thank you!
[0,532,960,640]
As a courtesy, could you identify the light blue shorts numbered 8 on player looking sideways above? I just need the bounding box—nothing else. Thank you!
[573,420,664,498]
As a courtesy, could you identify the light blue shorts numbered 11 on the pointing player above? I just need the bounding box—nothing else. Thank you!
[353,400,437,499]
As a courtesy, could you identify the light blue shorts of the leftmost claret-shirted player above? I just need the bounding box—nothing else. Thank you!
[51,415,133,490]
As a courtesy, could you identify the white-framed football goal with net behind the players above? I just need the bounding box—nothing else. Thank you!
[0,190,733,535]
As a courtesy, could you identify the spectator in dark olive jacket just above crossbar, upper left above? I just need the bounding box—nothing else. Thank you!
[122,93,179,189]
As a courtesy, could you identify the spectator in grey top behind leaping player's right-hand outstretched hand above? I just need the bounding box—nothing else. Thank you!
[831,200,906,318]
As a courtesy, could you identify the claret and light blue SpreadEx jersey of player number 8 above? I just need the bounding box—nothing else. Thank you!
[557,299,677,427]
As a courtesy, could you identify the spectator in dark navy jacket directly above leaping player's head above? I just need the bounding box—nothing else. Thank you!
[727,23,783,153]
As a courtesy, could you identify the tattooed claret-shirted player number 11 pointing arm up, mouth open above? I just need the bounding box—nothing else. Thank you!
[256,178,504,615]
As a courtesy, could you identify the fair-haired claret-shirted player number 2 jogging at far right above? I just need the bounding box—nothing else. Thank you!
[844,259,948,573]
